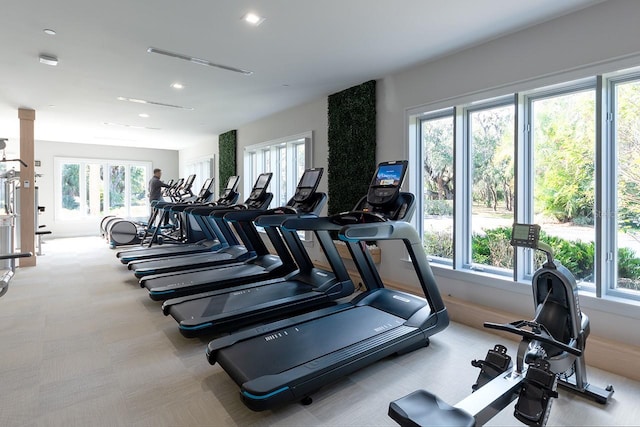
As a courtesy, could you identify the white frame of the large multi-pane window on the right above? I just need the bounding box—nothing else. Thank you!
[405,67,640,304]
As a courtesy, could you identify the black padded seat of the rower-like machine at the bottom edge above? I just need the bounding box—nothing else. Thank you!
[389,390,476,427]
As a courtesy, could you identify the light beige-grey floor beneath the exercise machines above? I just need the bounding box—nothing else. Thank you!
[0,237,640,427]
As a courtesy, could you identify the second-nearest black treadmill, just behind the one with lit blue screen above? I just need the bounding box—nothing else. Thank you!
[162,168,355,338]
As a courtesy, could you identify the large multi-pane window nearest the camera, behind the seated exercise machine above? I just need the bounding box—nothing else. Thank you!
[407,66,640,300]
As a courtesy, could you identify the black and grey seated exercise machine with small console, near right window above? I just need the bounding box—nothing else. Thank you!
[389,224,614,427]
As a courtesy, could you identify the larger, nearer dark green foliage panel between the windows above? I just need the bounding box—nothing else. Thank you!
[328,80,376,214]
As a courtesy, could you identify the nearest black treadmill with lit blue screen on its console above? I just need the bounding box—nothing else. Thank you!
[206,161,449,411]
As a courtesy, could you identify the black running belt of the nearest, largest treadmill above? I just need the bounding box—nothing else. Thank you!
[218,306,405,384]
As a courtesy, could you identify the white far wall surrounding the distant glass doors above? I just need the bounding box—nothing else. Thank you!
[35,141,178,237]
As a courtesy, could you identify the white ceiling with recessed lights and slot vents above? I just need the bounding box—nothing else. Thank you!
[0,0,601,149]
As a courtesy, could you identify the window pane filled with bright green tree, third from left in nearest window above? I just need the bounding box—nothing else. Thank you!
[527,84,596,287]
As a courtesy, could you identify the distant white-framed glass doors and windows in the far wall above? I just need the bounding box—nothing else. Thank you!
[54,158,151,220]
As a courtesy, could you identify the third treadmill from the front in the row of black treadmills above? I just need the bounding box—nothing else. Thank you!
[140,174,325,301]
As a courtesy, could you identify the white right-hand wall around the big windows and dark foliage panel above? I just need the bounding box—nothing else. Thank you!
[188,0,640,345]
